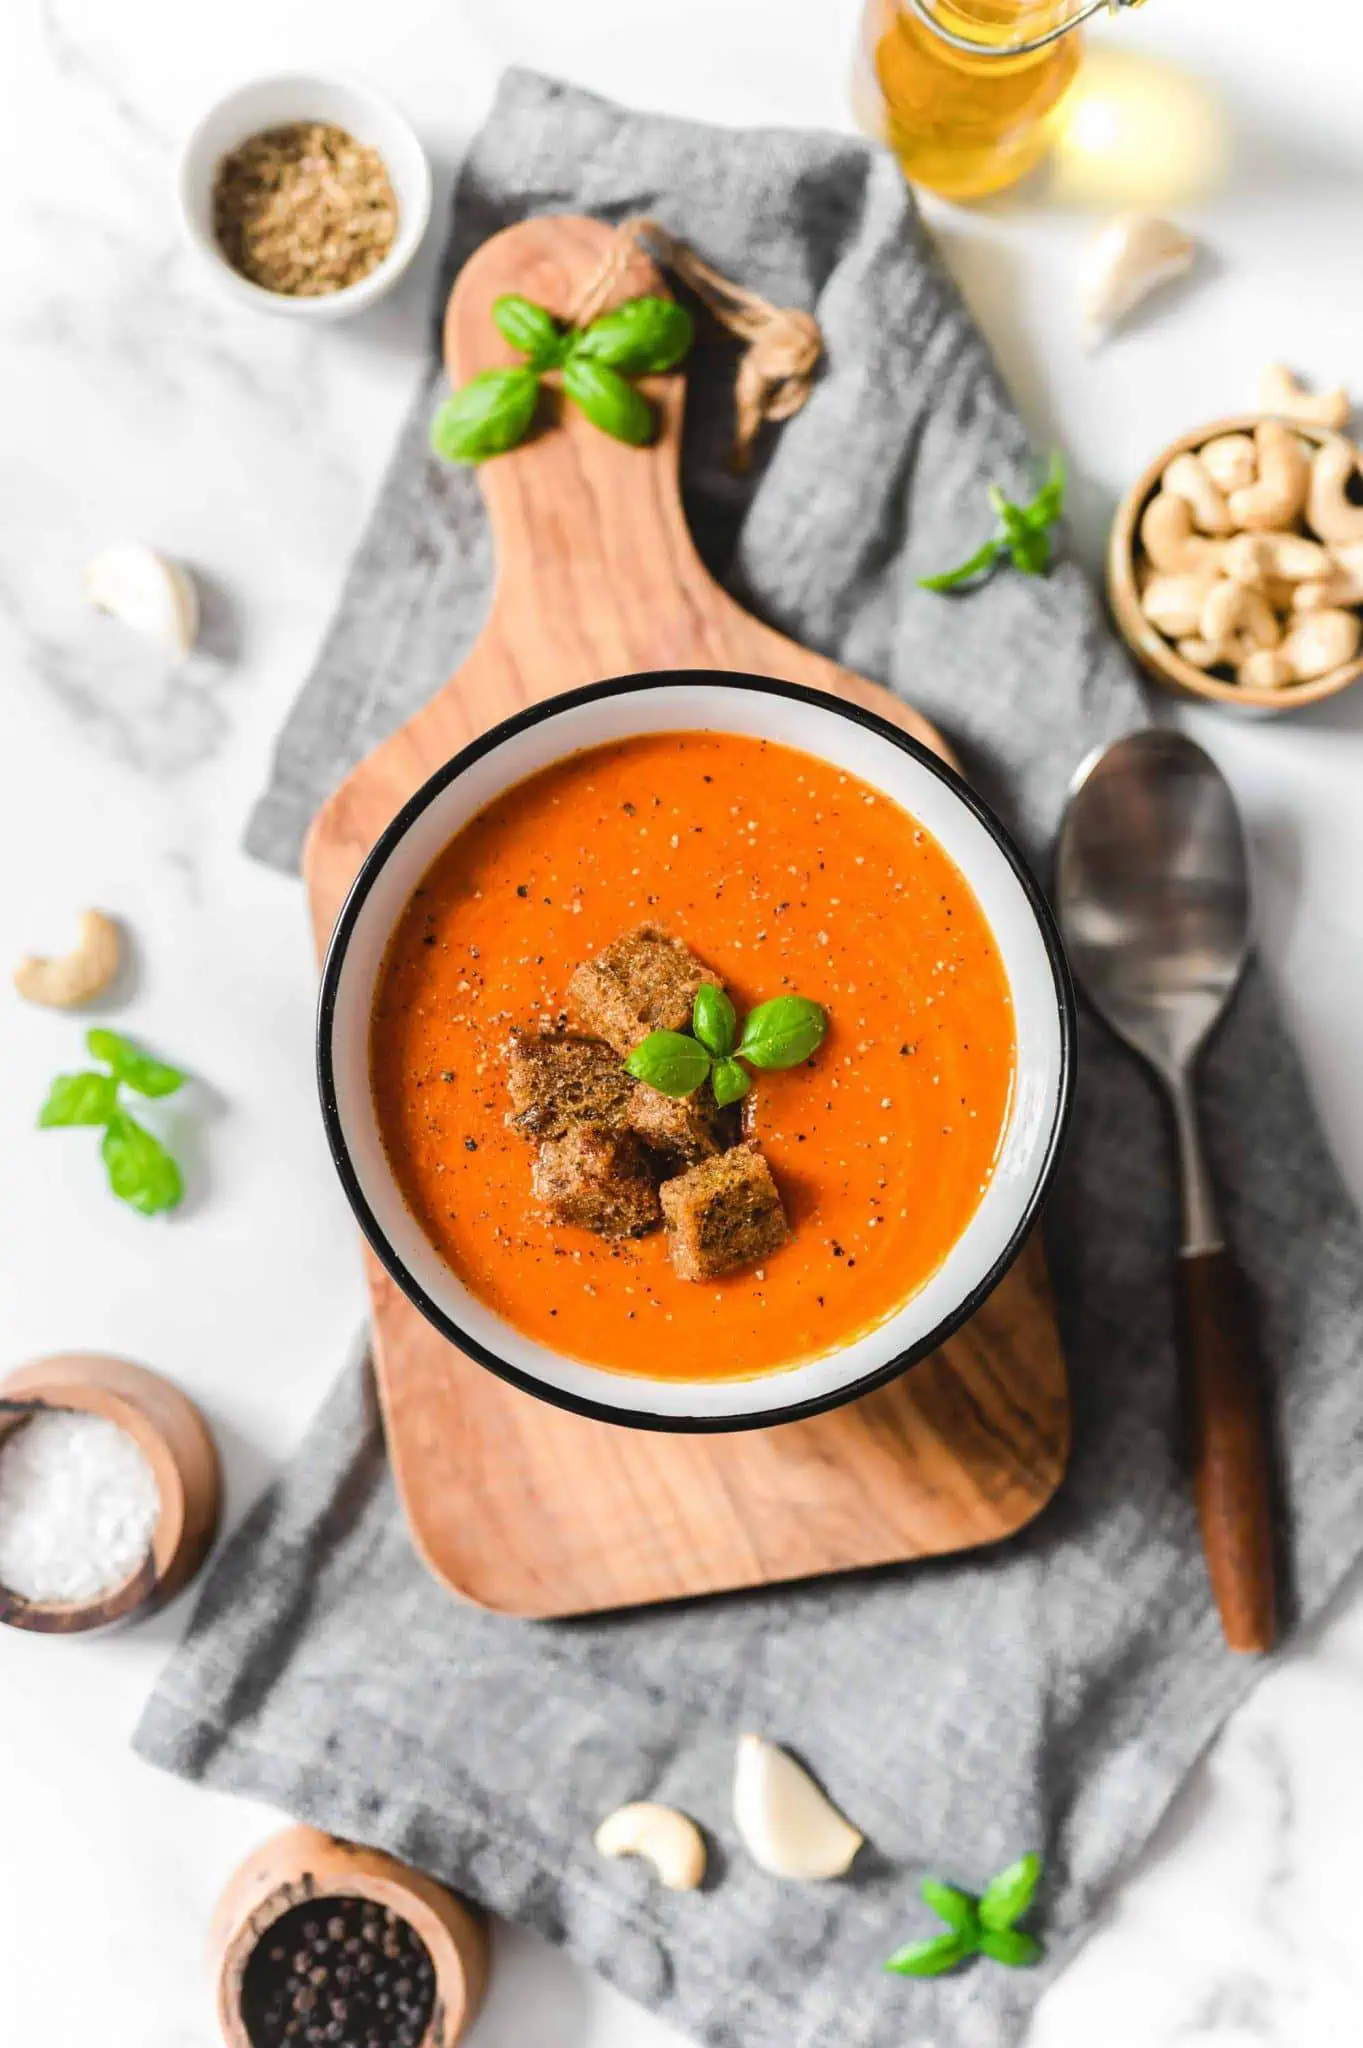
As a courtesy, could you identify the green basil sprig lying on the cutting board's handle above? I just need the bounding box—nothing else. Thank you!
[430,291,694,463]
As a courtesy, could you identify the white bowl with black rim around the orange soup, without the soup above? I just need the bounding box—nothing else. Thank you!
[317,670,1074,1430]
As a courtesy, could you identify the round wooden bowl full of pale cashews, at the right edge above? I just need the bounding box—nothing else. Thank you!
[1107,385,1363,711]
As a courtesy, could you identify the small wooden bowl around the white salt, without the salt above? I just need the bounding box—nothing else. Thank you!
[0,1352,223,1636]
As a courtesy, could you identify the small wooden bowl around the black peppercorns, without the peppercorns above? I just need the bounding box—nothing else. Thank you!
[209,1827,487,2048]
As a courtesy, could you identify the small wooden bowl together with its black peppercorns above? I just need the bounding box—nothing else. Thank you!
[209,1827,487,2048]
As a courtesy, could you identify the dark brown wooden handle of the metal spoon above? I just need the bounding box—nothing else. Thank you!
[1179,1247,1275,1651]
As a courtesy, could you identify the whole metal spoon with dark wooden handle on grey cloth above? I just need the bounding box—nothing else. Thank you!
[1056,731,1275,1651]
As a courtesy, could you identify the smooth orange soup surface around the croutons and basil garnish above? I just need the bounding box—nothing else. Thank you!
[370,731,1015,1378]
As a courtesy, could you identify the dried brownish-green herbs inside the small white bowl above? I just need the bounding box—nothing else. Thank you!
[213,121,397,299]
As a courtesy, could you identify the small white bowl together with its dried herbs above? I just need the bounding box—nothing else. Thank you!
[180,72,432,319]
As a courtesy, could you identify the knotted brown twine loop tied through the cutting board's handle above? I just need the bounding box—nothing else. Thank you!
[573,213,823,469]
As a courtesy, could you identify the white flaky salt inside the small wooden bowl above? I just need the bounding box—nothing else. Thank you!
[0,1409,160,1602]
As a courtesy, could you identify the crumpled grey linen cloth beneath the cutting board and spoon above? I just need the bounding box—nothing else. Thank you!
[137,74,1363,2048]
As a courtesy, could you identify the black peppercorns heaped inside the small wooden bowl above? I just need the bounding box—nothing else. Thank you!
[241,1896,436,2048]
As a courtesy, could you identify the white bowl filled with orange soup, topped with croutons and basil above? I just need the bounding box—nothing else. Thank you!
[317,672,1074,1430]
